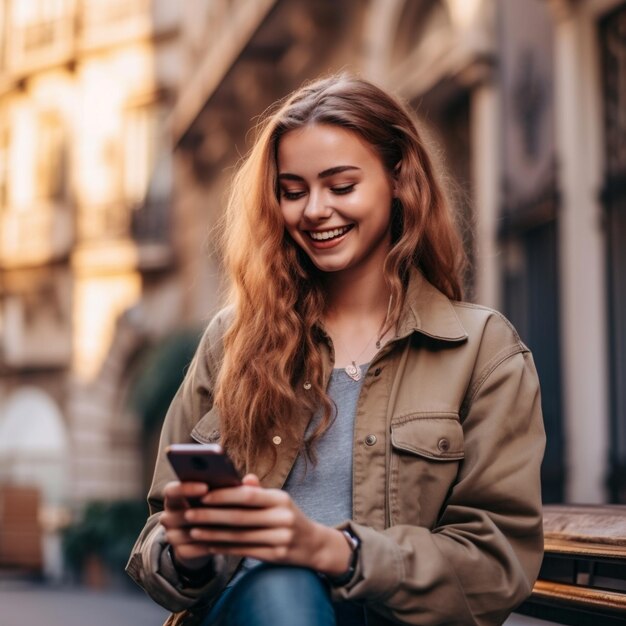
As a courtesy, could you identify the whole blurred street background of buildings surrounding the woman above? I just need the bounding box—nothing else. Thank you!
[0,0,626,626]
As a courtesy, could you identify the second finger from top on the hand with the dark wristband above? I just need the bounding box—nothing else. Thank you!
[183,506,295,528]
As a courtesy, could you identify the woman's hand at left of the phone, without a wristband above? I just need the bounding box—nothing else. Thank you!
[161,480,212,571]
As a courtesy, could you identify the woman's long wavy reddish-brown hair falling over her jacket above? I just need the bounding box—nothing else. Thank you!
[215,74,464,469]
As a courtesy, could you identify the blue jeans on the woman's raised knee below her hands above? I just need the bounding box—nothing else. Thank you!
[202,564,366,626]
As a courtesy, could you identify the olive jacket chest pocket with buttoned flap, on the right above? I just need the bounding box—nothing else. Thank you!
[389,413,464,528]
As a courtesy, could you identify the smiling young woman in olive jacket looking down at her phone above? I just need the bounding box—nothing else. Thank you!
[128,76,544,626]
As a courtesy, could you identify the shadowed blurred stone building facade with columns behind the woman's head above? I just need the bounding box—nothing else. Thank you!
[167,0,626,503]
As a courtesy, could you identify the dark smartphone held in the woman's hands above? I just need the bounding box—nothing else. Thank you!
[165,443,241,489]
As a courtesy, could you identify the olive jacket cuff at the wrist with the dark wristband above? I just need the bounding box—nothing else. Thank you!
[330,521,404,602]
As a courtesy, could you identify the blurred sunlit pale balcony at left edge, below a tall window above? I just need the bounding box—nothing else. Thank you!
[0,203,74,269]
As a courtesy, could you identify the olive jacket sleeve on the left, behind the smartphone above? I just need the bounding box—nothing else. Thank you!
[126,315,234,611]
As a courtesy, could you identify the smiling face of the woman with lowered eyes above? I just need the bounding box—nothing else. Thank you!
[278,124,393,272]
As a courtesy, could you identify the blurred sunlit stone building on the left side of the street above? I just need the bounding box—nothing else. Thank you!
[0,0,206,575]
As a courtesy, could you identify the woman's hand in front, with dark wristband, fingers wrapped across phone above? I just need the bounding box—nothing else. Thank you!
[185,474,352,576]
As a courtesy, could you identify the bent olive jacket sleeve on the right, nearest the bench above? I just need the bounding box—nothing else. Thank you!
[333,344,545,626]
